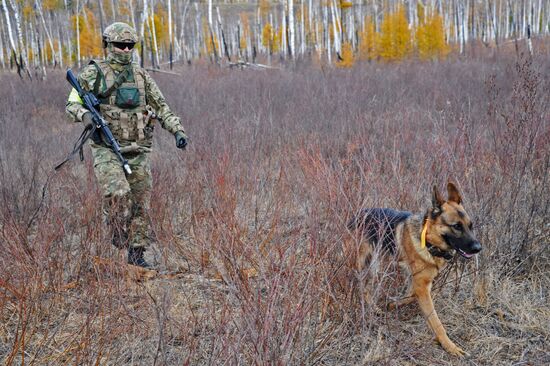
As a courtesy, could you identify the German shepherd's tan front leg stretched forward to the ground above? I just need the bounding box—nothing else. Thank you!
[413,273,466,356]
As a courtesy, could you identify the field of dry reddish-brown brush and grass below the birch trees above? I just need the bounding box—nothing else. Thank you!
[0,55,550,365]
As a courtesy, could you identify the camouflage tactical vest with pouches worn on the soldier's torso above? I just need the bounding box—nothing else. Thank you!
[90,60,154,145]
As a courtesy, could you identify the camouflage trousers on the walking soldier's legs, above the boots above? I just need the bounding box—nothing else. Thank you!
[91,144,152,248]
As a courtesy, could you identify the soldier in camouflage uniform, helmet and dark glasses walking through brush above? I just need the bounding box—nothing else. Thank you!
[66,22,188,268]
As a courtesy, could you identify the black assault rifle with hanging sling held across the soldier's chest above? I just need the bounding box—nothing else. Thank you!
[55,69,132,175]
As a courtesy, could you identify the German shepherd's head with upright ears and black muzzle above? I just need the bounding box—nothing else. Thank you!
[426,182,481,258]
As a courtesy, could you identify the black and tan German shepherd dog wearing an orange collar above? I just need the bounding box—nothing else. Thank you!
[348,183,481,356]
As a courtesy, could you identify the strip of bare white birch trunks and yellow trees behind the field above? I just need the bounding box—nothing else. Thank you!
[0,0,550,76]
